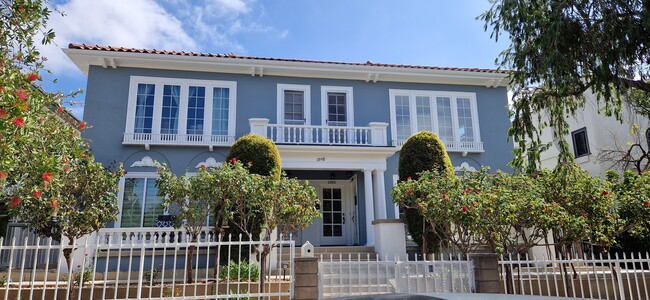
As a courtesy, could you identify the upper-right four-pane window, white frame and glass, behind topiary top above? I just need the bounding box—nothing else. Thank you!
[389,89,481,145]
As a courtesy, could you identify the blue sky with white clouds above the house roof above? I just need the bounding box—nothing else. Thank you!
[41,0,508,118]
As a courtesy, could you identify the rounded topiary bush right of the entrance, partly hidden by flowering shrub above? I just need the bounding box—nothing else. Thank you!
[398,131,454,253]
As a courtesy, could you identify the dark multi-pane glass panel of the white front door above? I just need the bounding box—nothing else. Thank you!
[320,185,348,245]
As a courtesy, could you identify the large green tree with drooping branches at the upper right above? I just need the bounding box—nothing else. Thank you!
[480,0,650,170]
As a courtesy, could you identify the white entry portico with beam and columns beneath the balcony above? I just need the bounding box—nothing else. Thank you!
[278,145,397,246]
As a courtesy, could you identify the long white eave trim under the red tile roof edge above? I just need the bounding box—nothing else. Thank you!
[62,49,509,87]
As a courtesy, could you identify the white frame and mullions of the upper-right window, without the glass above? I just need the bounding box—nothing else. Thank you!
[388,89,482,142]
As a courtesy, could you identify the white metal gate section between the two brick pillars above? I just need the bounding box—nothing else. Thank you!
[318,255,475,298]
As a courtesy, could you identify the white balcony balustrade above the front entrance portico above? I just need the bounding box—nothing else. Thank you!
[249,119,388,147]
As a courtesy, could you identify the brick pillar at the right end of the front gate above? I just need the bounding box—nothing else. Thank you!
[469,253,501,294]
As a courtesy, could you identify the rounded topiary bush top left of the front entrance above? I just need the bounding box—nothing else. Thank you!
[227,134,282,179]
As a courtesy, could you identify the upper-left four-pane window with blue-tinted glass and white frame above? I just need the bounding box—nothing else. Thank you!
[125,76,237,140]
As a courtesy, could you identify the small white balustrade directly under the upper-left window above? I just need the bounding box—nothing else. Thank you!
[122,132,235,146]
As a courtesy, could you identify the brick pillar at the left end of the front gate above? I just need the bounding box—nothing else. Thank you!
[294,257,319,300]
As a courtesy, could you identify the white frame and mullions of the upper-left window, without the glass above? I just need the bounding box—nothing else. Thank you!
[125,76,237,136]
